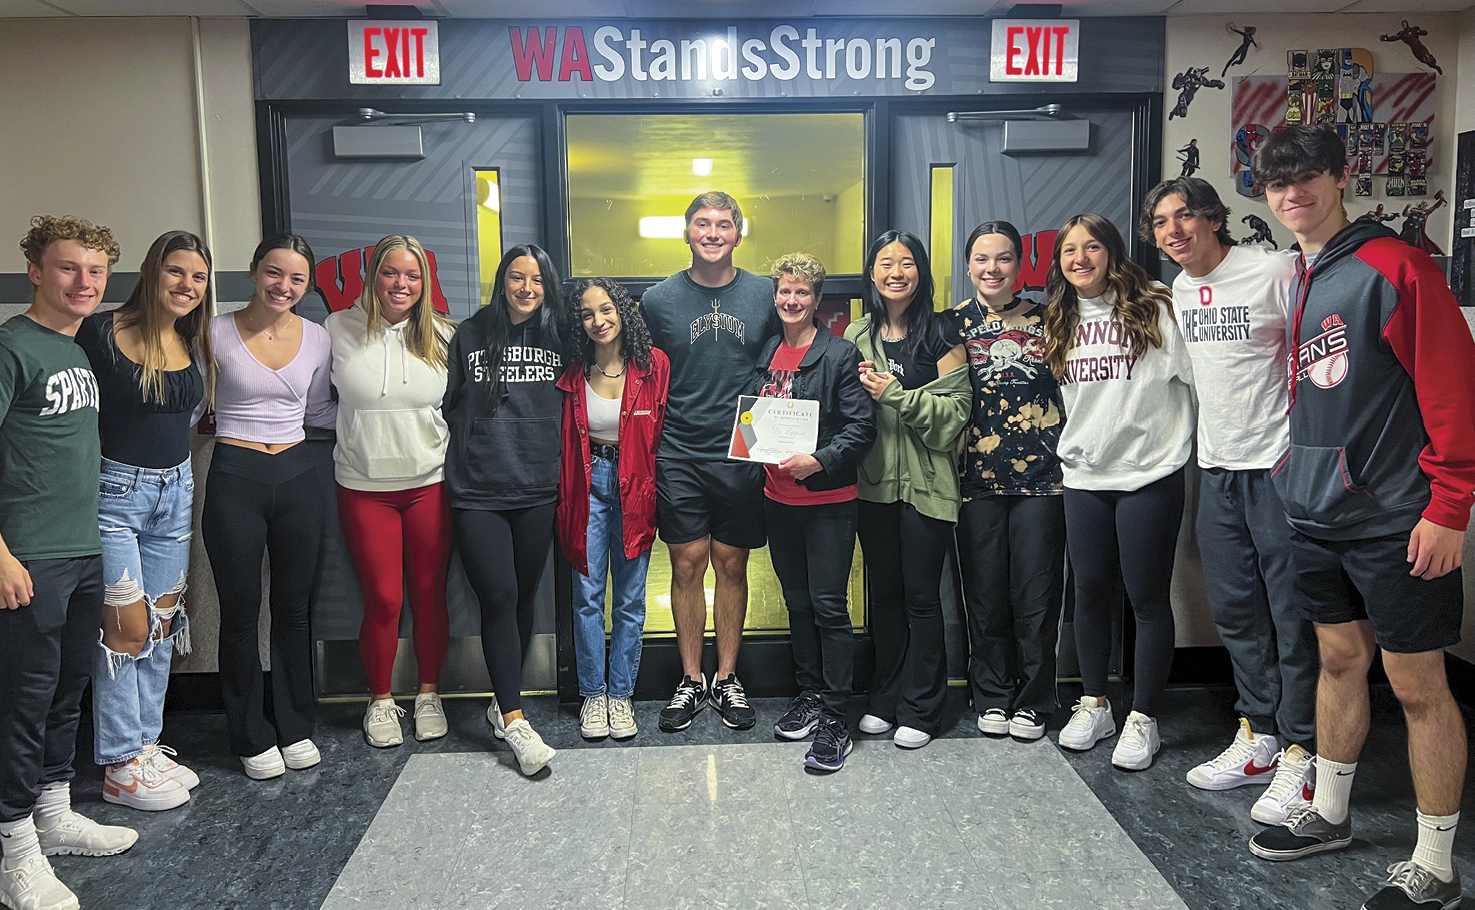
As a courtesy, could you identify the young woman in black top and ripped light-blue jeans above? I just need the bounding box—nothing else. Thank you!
[77,230,214,810]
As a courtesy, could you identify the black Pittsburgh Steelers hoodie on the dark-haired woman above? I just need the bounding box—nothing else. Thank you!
[441,307,563,510]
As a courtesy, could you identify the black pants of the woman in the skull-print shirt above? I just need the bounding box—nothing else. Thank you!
[957,496,1065,717]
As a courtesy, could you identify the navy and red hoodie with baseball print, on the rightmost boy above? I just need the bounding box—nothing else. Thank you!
[1271,221,1475,540]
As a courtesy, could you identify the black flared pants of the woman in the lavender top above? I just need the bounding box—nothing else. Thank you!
[199,444,326,755]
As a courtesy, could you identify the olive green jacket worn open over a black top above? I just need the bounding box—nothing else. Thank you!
[845,316,974,522]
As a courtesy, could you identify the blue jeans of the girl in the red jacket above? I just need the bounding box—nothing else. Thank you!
[574,456,650,698]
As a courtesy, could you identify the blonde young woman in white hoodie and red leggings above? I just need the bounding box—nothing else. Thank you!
[326,235,456,748]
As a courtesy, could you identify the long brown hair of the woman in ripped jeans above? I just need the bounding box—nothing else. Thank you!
[115,230,215,401]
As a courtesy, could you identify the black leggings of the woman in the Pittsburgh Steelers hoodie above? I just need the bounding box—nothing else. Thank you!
[451,503,556,714]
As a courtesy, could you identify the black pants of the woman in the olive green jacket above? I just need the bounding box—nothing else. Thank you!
[858,500,953,736]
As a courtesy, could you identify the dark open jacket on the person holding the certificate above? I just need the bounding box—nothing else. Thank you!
[749,320,876,493]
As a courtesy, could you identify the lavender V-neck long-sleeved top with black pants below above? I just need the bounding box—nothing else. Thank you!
[209,313,338,444]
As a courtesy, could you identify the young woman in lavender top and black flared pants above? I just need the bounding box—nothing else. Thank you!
[201,235,335,780]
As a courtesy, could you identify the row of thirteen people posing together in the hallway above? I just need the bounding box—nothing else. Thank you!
[0,127,1475,910]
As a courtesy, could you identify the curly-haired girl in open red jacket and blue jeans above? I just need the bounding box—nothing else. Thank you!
[556,279,671,739]
